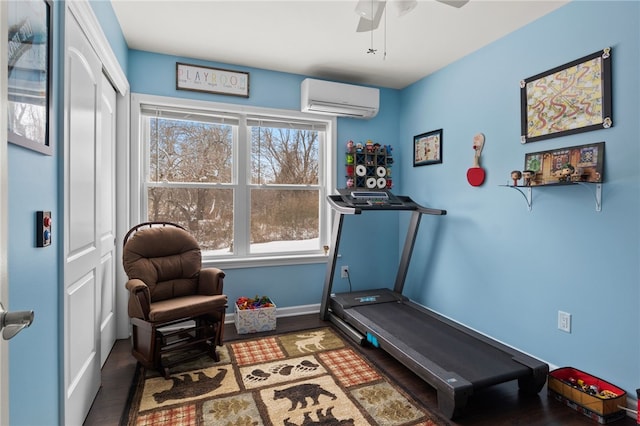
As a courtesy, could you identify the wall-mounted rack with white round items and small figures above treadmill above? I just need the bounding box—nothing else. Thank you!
[345,140,393,189]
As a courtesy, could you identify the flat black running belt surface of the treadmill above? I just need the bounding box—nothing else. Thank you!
[346,303,530,388]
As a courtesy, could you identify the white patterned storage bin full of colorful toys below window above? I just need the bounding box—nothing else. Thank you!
[235,296,276,334]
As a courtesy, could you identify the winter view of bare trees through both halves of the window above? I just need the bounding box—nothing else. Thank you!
[145,110,324,256]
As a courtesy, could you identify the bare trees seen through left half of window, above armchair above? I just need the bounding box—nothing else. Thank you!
[147,118,233,251]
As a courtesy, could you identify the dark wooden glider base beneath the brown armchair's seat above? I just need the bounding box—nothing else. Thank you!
[130,306,225,379]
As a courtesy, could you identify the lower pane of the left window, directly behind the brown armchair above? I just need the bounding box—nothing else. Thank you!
[148,187,233,255]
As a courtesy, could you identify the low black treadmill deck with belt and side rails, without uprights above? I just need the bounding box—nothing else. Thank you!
[330,289,549,418]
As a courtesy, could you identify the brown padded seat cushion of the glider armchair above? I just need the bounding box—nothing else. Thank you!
[149,295,227,323]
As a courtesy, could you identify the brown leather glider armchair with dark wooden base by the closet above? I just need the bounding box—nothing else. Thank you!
[122,222,227,377]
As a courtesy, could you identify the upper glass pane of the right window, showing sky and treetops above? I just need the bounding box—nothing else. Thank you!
[250,126,319,185]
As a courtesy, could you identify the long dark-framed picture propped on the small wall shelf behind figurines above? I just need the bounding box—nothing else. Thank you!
[524,142,604,186]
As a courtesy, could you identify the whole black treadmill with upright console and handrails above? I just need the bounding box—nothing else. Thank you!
[320,189,549,419]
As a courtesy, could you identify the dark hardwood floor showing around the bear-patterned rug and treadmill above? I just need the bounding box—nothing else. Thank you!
[84,315,636,426]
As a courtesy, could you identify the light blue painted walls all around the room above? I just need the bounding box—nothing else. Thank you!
[8,0,640,425]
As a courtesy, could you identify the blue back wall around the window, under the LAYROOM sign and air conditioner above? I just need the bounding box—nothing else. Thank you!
[128,50,400,308]
